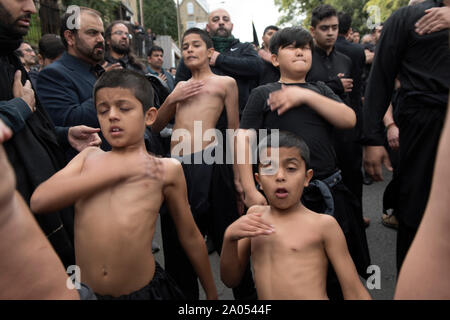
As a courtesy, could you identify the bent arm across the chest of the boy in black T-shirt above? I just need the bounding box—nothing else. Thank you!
[268,86,356,129]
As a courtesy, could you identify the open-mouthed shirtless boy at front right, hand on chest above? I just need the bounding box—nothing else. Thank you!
[220,131,370,300]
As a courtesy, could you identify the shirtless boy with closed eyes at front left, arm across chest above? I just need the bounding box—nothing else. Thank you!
[31,70,217,299]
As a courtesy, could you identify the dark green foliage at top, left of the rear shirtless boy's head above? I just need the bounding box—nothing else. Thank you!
[143,0,178,41]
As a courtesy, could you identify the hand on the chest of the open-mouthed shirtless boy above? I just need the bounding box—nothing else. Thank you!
[226,212,275,241]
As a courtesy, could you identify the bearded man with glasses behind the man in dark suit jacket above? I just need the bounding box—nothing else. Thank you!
[105,21,145,73]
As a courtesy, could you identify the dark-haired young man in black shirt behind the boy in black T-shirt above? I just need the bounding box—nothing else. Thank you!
[307,5,364,225]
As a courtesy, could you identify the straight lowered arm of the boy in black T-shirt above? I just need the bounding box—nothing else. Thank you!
[236,129,267,208]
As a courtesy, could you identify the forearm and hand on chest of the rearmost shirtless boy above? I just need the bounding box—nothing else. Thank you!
[151,80,204,133]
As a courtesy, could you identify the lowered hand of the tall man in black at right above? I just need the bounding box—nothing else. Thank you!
[363,146,392,181]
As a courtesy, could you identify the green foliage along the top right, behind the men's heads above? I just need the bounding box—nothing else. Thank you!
[274,0,409,33]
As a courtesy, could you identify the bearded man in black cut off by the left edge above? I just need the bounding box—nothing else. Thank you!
[0,0,99,268]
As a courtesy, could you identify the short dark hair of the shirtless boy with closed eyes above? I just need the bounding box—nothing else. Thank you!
[94,69,154,113]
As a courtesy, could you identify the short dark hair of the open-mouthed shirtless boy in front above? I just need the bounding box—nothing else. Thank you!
[258,131,310,170]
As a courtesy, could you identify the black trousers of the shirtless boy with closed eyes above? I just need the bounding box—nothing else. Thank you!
[96,260,184,301]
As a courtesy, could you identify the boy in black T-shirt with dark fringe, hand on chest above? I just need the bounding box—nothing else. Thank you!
[238,28,370,298]
